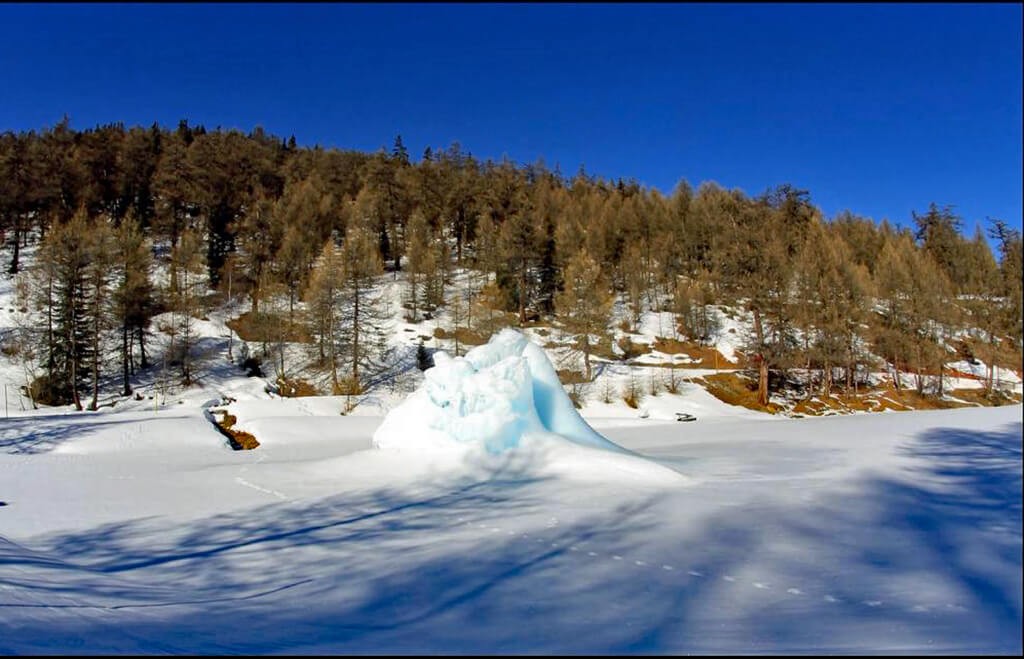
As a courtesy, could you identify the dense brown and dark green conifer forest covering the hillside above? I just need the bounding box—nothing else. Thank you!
[0,119,1022,409]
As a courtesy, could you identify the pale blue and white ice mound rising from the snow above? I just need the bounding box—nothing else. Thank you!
[373,330,630,453]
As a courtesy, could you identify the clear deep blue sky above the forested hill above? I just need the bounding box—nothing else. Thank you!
[0,3,1024,232]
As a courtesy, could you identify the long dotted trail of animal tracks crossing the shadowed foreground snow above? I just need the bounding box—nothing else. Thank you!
[459,517,968,613]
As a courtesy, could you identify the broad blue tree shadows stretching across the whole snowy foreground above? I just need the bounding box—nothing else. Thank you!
[0,424,1021,654]
